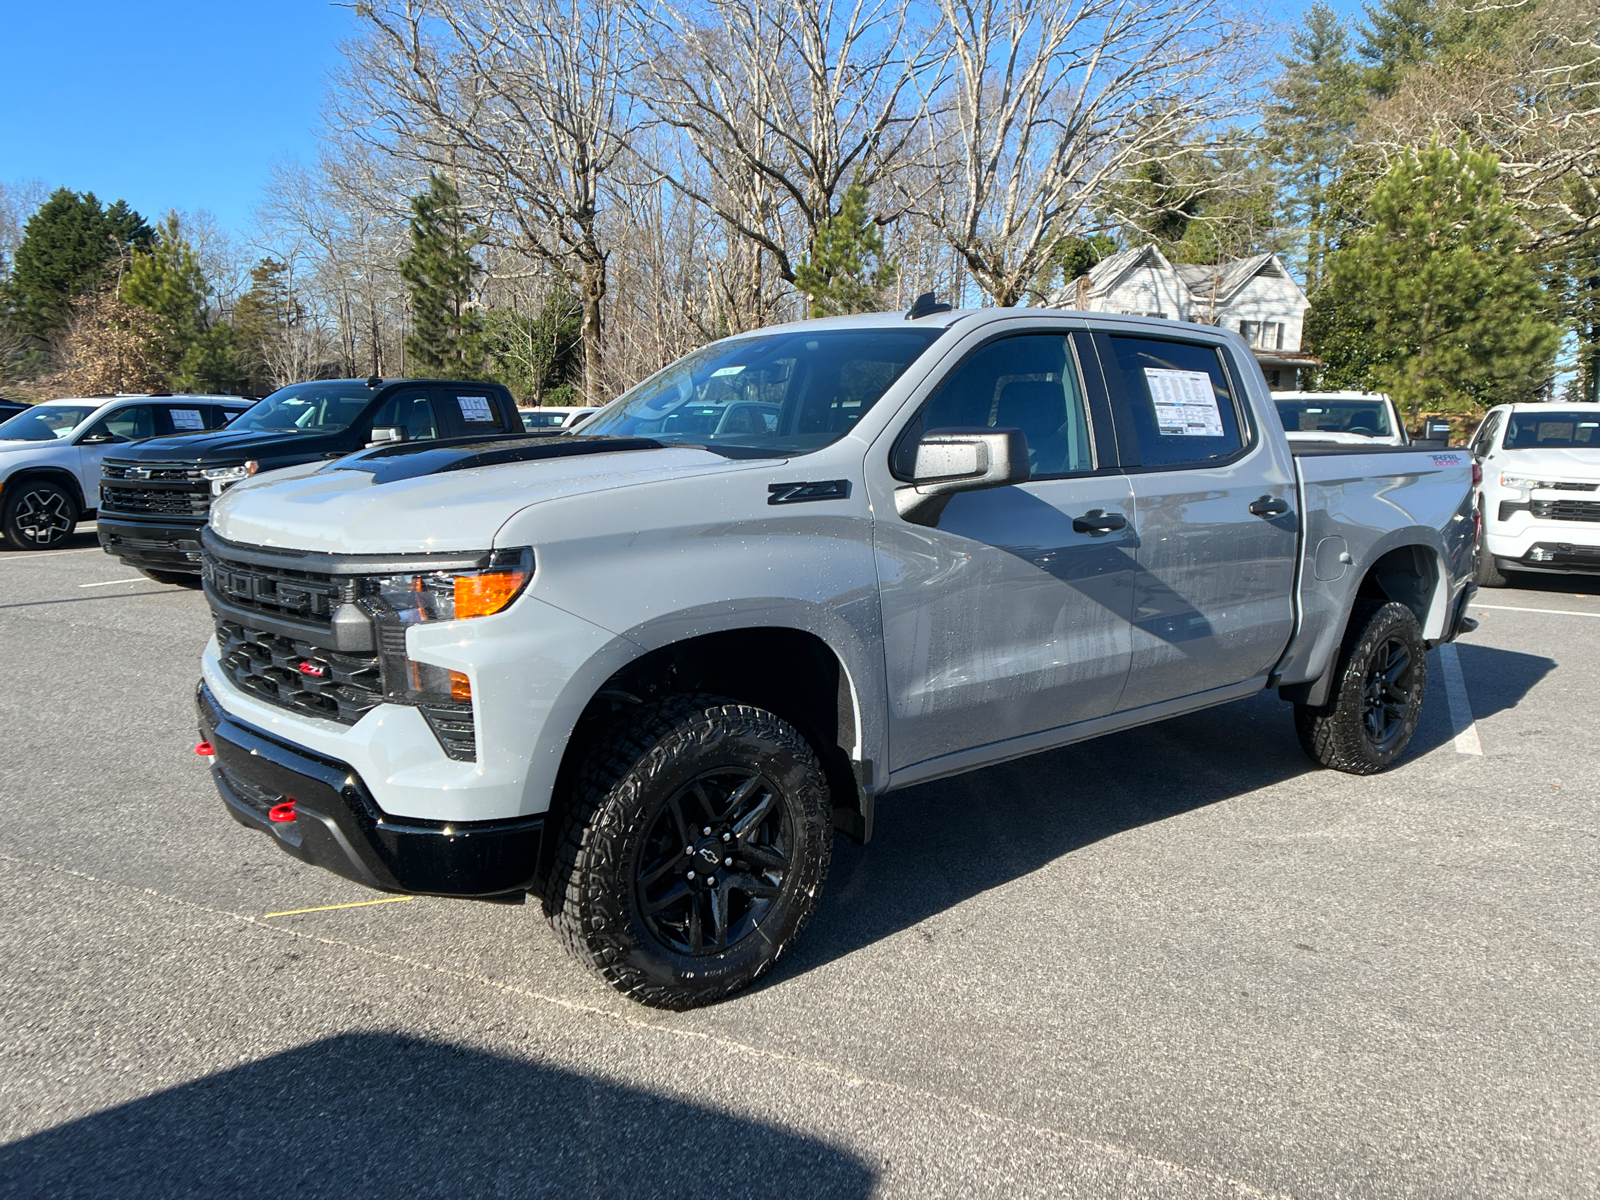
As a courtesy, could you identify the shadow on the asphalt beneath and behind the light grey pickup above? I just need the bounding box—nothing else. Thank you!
[780,642,1555,982]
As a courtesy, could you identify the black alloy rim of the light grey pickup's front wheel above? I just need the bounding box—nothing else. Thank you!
[634,768,794,955]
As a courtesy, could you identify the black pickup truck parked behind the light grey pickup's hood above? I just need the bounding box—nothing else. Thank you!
[99,376,523,587]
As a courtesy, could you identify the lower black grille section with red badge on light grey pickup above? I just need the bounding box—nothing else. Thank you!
[216,621,385,723]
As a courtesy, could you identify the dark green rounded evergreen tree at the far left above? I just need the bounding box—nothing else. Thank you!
[5,187,155,341]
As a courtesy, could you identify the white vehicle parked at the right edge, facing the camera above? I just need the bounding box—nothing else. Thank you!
[1469,405,1600,587]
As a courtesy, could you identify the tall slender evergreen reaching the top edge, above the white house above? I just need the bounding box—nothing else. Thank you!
[1262,2,1366,290]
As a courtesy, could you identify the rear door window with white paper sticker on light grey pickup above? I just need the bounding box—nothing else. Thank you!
[1101,334,1245,467]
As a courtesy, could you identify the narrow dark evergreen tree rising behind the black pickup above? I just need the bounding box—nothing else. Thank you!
[400,171,483,378]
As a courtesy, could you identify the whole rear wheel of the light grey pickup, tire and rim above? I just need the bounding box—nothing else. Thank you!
[1294,600,1427,774]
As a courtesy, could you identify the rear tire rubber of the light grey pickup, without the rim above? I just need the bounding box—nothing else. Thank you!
[1294,600,1427,774]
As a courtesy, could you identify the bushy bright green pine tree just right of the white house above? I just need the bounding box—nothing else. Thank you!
[1307,138,1560,421]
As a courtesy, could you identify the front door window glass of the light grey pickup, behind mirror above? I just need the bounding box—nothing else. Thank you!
[894,333,1094,478]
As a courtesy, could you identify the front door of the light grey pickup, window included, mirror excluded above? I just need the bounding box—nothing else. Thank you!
[875,328,1134,770]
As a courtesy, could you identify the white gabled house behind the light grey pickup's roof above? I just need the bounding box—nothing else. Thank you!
[1050,246,1320,389]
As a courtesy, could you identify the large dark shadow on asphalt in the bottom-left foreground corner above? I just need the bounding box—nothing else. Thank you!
[0,1034,874,1200]
